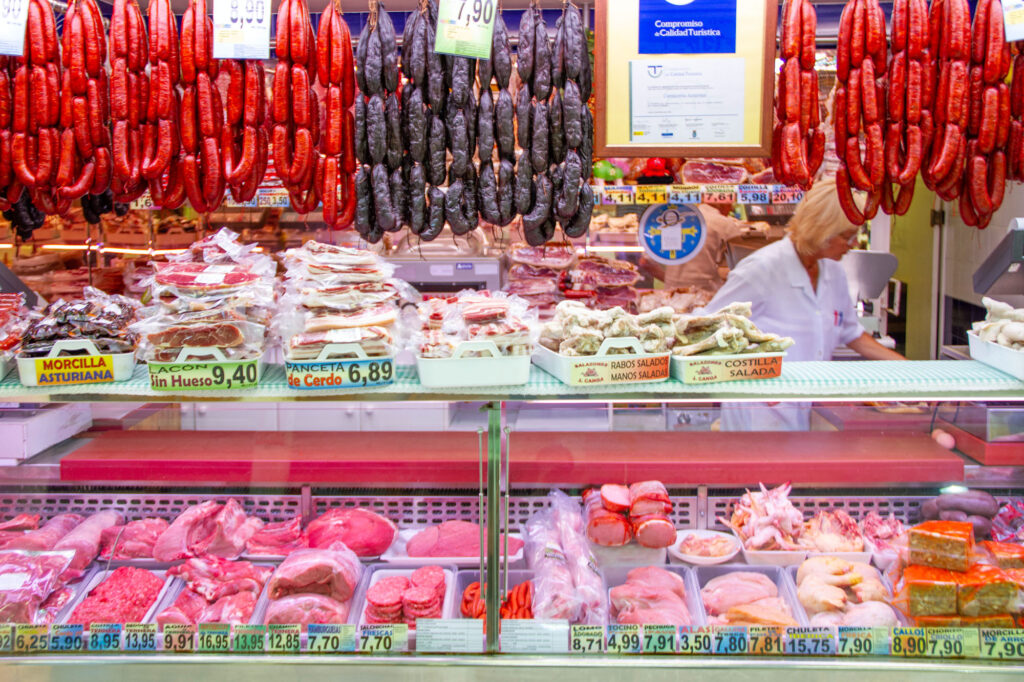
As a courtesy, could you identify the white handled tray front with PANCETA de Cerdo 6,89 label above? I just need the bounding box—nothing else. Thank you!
[285,343,394,390]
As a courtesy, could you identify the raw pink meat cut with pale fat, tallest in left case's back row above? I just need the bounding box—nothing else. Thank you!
[153,498,263,561]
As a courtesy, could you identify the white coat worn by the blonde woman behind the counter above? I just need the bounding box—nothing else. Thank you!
[706,237,864,431]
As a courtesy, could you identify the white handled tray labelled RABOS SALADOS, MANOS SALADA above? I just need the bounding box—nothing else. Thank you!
[534,337,671,386]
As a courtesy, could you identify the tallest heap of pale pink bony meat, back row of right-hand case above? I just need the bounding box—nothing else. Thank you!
[719,483,804,551]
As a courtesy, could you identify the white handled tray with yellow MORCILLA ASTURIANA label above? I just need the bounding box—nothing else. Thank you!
[17,339,135,386]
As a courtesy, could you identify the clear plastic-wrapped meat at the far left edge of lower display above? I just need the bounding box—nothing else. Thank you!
[0,550,73,623]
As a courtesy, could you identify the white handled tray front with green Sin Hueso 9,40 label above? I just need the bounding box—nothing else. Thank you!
[148,347,263,391]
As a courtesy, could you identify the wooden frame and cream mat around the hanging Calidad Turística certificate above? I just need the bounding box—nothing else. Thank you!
[594,0,779,158]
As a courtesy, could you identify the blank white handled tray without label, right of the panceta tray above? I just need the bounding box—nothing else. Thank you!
[416,341,529,388]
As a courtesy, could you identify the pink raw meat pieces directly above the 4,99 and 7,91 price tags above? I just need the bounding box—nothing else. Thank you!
[609,566,692,626]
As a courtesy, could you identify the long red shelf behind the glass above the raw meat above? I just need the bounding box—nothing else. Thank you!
[60,431,964,487]
